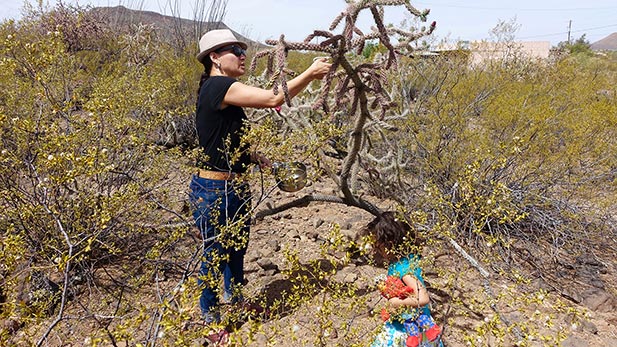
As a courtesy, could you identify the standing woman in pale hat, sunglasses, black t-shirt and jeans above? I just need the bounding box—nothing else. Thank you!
[190,29,331,339]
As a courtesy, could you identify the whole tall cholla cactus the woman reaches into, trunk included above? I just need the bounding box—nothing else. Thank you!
[251,0,435,215]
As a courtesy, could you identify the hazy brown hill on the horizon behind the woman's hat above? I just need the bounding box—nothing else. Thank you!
[91,6,265,48]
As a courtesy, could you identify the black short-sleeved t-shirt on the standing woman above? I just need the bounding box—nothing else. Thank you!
[195,76,251,173]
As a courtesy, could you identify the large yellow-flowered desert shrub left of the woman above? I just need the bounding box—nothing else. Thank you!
[0,5,200,343]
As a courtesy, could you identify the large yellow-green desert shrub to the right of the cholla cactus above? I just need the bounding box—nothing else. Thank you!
[358,47,615,243]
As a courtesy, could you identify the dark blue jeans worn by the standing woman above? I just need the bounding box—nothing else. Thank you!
[189,175,251,320]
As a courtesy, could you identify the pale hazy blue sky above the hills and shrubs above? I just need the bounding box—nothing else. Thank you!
[0,0,617,45]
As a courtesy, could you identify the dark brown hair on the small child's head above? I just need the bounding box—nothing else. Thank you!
[363,211,422,253]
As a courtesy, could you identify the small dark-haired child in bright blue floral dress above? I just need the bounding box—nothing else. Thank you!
[364,212,441,347]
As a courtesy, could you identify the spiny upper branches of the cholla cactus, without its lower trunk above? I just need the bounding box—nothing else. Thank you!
[251,0,435,116]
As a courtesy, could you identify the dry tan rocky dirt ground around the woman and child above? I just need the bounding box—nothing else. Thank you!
[7,178,617,347]
